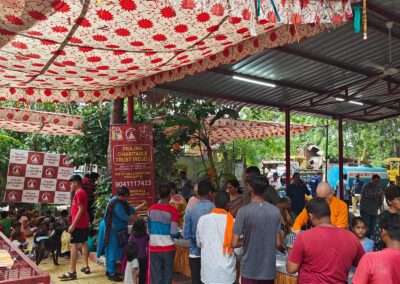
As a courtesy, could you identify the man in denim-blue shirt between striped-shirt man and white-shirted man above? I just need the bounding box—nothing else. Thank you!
[183,180,215,284]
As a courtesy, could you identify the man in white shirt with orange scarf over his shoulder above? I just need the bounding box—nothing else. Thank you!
[196,192,236,284]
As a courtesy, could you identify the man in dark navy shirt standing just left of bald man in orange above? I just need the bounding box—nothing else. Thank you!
[286,173,310,216]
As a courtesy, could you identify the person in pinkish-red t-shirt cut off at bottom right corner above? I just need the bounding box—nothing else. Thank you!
[353,213,400,284]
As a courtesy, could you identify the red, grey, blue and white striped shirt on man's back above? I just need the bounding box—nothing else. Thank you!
[149,203,179,252]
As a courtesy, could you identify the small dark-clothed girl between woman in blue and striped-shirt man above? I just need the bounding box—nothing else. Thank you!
[128,219,150,284]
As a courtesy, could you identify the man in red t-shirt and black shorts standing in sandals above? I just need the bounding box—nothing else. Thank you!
[59,175,90,281]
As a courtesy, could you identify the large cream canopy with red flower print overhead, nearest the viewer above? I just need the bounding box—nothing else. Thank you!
[0,0,352,102]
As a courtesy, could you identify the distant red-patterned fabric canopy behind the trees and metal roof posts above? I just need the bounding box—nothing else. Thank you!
[164,118,313,145]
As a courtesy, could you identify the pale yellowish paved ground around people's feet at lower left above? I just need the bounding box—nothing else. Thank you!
[39,253,191,284]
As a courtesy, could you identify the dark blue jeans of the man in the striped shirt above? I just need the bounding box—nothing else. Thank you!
[150,251,175,284]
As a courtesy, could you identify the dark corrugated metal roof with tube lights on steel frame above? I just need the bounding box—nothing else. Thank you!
[154,0,400,121]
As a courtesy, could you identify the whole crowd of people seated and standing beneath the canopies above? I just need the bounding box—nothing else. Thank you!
[0,167,400,284]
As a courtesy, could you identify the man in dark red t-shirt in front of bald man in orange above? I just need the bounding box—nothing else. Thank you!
[286,197,365,284]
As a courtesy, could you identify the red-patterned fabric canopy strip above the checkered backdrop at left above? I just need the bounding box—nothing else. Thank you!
[0,107,83,136]
